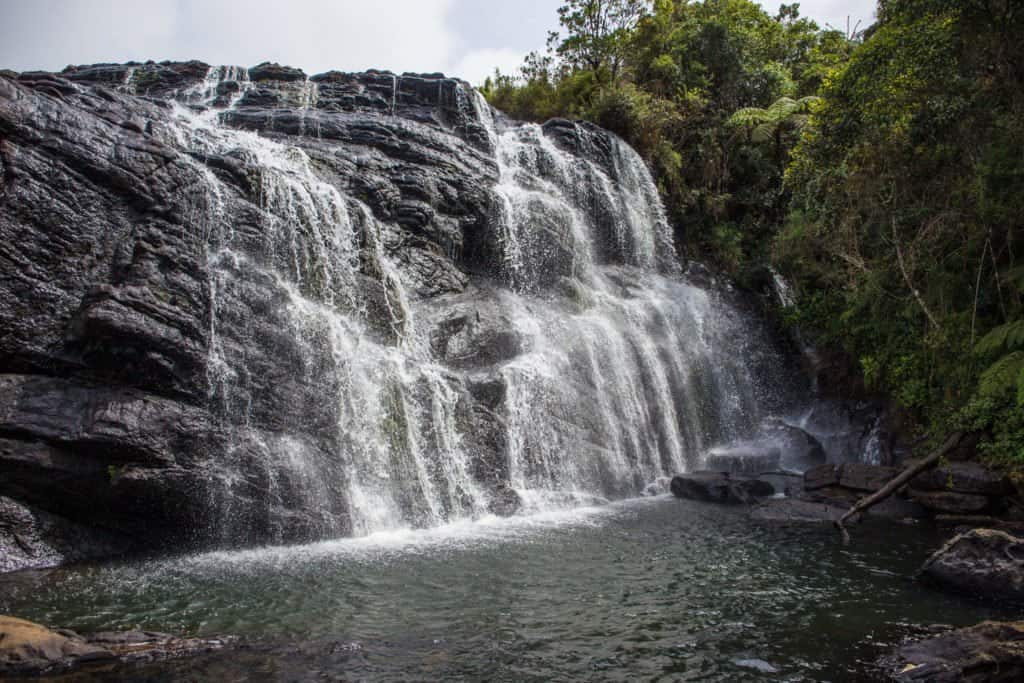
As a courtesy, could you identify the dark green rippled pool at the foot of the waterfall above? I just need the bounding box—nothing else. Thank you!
[0,497,1010,681]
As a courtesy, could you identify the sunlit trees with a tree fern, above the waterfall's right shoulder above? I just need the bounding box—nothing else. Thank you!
[483,0,852,272]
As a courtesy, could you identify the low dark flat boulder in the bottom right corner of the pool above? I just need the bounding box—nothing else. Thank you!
[882,622,1024,683]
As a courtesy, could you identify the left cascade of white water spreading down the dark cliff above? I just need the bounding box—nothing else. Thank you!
[166,68,486,541]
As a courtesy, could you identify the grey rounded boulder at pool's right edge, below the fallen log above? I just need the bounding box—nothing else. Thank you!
[921,528,1024,602]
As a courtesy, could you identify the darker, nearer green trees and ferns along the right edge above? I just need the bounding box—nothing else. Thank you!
[773,0,1024,468]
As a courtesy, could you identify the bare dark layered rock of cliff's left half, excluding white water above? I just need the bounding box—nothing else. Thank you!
[0,62,507,570]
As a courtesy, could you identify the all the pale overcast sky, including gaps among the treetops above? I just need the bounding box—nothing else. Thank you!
[0,0,874,83]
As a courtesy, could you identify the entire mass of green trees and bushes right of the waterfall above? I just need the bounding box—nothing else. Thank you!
[483,0,1024,468]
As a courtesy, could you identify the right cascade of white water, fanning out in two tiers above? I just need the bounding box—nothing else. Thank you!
[478,101,790,500]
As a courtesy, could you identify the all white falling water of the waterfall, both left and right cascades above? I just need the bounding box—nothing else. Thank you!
[168,68,790,543]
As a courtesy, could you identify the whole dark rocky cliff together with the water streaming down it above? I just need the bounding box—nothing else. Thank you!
[0,62,787,570]
